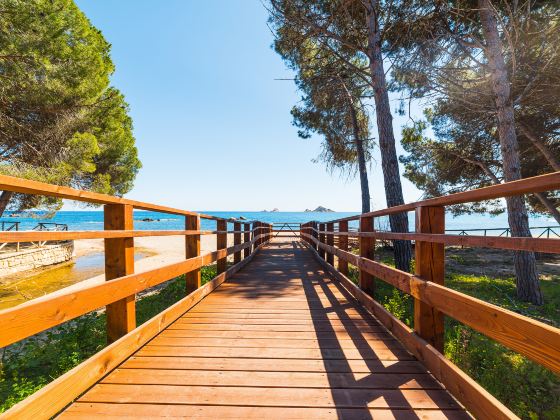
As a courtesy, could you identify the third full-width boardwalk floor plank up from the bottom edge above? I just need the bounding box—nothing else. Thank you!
[100,368,442,389]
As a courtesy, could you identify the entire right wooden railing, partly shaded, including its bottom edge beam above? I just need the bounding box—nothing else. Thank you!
[301,172,560,418]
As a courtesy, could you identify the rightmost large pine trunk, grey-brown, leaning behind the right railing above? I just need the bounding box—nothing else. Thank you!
[478,0,543,305]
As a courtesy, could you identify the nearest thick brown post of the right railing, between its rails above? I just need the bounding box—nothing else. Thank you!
[414,207,445,353]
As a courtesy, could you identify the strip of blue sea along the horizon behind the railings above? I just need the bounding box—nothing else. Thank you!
[0,210,558,235]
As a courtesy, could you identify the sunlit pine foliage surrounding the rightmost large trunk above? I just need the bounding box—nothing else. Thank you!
[394,4,560,214]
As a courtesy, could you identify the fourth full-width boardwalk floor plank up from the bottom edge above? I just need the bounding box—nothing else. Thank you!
[122,355,427,377]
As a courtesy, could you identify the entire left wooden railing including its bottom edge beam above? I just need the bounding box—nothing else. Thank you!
[0,176,272,418]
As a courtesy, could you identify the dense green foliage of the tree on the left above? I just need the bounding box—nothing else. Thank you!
[0,0,141,210]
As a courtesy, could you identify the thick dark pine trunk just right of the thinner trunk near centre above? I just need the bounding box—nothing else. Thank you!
[367,0,412,271]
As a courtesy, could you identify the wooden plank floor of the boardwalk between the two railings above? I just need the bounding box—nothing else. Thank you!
[60,238,468,419]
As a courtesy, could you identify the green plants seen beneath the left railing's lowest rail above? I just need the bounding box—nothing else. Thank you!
[0,266,216,412]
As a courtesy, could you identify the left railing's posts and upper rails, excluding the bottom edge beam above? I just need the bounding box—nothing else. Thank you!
[0,175,272,346]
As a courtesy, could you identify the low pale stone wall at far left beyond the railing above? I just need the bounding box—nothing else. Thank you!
[0,241,74,277]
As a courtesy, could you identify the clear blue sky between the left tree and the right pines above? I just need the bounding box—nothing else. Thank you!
[77,0,421,211]
